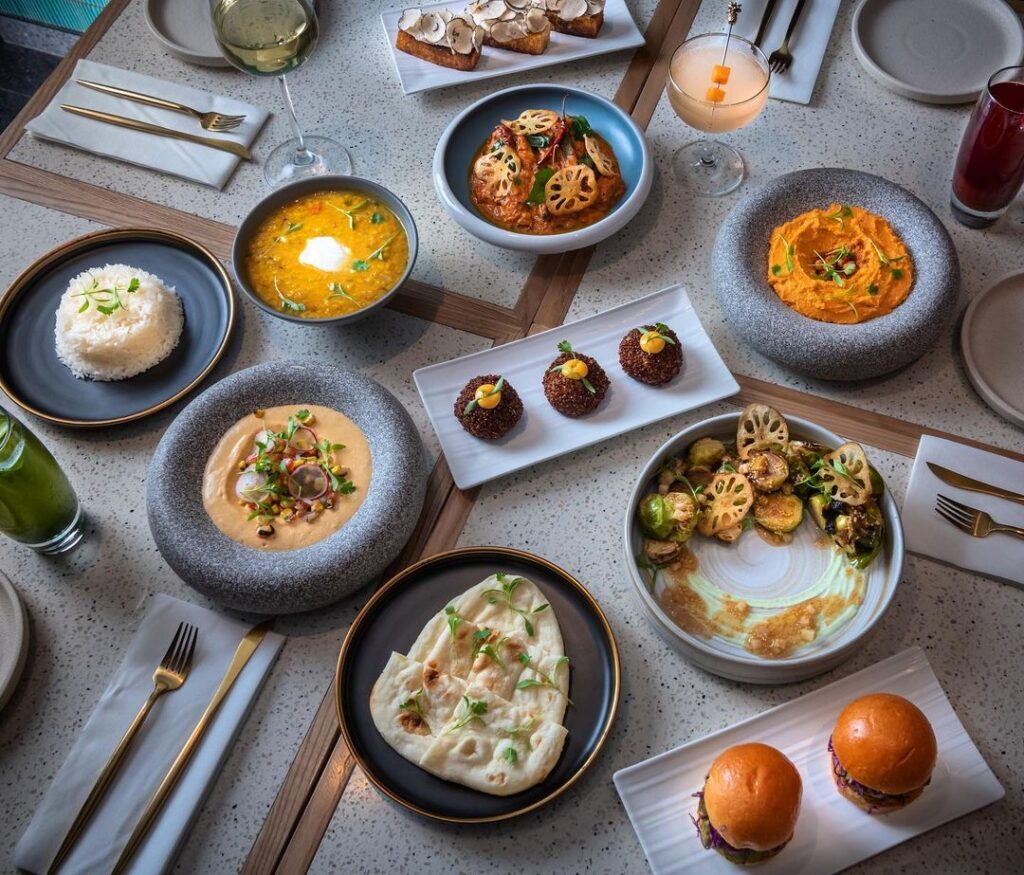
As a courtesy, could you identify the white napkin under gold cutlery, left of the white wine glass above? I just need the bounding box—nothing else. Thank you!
[26,60,269,189]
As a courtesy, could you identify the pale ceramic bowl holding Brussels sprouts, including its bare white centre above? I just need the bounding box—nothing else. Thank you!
[624,410,903,683]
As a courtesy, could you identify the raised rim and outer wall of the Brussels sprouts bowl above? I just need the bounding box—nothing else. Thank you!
[624,413,903,683]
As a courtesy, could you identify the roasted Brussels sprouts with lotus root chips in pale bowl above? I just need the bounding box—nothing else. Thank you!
[637,404,885,569]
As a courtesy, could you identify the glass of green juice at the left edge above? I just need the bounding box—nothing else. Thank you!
[0,408,83,555]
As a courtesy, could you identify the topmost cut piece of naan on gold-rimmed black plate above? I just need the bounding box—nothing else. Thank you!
[452,572,565,656]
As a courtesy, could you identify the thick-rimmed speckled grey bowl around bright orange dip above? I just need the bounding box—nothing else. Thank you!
[712,167,961,380]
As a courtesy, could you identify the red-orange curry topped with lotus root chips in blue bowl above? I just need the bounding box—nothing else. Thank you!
[469,110,626,235]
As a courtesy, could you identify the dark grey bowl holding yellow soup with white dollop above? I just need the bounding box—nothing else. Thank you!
[231,174,420,325]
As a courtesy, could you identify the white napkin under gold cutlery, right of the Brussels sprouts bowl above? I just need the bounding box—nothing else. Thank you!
[903,434,1024,584]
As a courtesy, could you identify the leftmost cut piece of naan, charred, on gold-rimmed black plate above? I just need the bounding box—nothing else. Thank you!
[370,653,466,762]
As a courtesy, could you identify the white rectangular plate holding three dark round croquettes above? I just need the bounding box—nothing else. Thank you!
[413,286,739,489]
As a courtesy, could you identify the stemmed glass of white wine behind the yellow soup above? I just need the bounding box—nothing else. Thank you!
[210,0,352,189]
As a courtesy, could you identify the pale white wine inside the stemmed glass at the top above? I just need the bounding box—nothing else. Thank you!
[213,0,318,76]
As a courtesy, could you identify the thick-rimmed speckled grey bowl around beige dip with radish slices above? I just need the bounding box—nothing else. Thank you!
[145,361,427,614]
